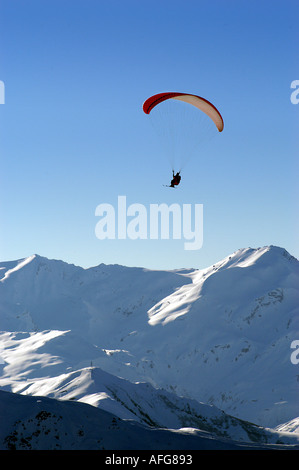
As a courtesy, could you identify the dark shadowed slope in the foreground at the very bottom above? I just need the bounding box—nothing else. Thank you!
[0,391,299,450]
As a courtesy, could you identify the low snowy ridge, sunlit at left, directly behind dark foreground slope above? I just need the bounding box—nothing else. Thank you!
[5,368,299,445]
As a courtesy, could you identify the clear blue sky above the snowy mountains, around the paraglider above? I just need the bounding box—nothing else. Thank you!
[0,0,299,269]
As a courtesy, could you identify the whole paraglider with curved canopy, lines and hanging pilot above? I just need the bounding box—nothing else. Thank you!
[143,92,224,188]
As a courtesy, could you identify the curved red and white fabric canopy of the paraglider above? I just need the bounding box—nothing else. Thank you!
[143,92,224,132]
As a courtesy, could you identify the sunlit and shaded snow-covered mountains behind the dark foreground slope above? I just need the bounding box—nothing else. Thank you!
[0,246,299,448]
